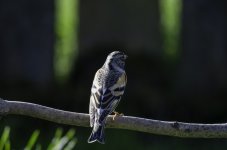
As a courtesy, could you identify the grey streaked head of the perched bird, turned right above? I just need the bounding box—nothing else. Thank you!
[105,51,128,69]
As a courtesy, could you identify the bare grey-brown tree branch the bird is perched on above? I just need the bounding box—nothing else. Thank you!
[0,99,227,138]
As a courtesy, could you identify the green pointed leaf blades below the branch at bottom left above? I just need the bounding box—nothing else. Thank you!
[0,127,77,150]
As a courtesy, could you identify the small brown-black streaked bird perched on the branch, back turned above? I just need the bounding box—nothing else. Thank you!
[88,51,127,144]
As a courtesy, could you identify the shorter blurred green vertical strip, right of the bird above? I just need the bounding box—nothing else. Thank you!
[159,0,182,59]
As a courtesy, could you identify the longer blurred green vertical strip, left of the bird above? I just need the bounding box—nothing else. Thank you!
[54,0,79,83]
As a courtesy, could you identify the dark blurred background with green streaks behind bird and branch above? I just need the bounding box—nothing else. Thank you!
[0,0,227,150]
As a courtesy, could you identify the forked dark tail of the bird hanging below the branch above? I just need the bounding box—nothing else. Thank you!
[88,123,105,144]
